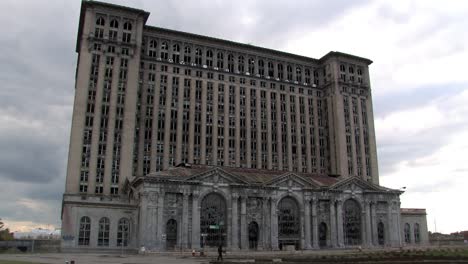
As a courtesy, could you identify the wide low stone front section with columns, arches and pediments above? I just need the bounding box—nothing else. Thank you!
[62,166,427,251]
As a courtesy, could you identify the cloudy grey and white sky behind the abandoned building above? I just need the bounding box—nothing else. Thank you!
[0,0,468,232]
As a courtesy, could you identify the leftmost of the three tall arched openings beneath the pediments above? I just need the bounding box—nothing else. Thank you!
[200,193,227,247]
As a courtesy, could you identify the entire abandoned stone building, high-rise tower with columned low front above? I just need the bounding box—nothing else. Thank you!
[62,1,427,250]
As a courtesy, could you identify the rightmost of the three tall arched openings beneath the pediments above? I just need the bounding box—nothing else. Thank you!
[343,199,362,246]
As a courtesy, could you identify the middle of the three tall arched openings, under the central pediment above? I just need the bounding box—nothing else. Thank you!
[278,197,301,249]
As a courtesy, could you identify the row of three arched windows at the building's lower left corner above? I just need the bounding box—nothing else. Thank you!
[78,216,130,247]
